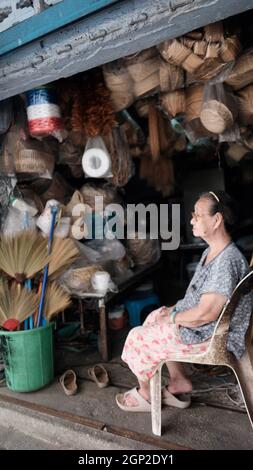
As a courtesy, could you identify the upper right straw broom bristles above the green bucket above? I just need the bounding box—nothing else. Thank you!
[48,238,79,280]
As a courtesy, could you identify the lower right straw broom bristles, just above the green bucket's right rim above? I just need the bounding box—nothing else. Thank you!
[44,282,71,321]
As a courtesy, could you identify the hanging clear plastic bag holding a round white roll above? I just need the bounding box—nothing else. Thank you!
[82,136,113,178]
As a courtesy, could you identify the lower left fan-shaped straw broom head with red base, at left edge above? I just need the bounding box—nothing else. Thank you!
[0,281,39,331]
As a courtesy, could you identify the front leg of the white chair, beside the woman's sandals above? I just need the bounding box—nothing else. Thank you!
[150,367,162,436]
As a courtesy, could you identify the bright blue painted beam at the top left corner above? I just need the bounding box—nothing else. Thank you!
[0,0,118,55]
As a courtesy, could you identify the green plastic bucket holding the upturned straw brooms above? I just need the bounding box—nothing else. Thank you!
[0,323,54,392]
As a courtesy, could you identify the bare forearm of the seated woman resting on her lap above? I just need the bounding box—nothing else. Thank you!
[171,293,227,328]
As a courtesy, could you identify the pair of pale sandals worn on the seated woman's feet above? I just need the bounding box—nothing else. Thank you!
[116,387,191,412]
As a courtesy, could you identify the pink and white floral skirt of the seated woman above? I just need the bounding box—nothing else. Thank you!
[122,307,210,382]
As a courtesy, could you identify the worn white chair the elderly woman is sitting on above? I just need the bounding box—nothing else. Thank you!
[150,269,253,436]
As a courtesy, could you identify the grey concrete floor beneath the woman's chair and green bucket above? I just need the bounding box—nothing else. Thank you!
[0,324,253,450]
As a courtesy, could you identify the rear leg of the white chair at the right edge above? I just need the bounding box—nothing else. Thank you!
[232,350,253,428]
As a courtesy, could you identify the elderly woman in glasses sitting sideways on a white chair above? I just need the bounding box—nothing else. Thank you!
[116,191,248,411]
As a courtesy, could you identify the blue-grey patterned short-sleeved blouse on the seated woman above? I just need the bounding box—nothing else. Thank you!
[175,242,253,359]
